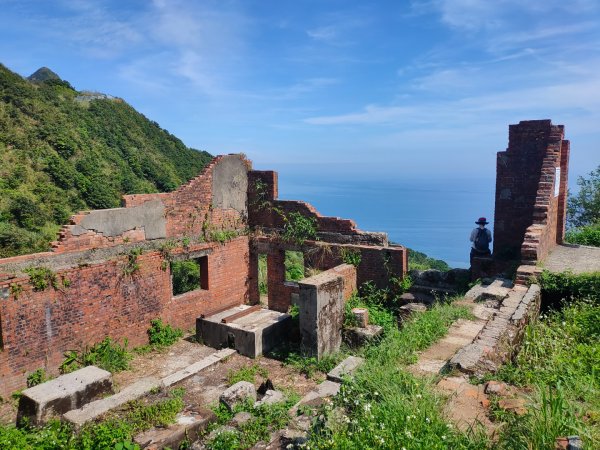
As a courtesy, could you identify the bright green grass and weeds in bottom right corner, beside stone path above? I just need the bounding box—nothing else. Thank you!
[498,301,600,449]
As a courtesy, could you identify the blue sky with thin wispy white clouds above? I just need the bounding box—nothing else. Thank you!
[0,0,600,184]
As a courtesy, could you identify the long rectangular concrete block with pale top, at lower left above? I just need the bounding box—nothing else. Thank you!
[17,366,112,425]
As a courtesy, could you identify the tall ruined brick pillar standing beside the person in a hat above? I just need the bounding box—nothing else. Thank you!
[494,120,569,261]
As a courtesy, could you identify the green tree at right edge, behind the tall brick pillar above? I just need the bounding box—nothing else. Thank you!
[567,166,600,227]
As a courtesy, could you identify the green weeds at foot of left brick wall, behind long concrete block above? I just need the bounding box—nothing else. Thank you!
[59,337,133,373]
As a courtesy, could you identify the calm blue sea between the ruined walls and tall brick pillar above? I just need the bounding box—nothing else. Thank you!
[279,173,495,267]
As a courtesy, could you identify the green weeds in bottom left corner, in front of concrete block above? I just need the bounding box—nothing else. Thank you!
[0,389,184,450]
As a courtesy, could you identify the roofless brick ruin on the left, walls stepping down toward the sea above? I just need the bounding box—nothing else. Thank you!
[0,155,408,396]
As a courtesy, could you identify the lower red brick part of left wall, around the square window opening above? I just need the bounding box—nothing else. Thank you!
[0,236,249,396]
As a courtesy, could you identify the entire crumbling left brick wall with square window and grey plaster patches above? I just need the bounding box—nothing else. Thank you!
[0,155,250,396]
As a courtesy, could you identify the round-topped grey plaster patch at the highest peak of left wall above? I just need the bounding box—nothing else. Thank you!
[212,155,248,216]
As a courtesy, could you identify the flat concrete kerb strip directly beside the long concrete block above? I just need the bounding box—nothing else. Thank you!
[63,377,162,428]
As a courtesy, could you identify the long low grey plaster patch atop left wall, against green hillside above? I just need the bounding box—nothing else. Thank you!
[71,199,167,239]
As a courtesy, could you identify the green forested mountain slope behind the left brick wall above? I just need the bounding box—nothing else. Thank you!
[0,64,211,257]
